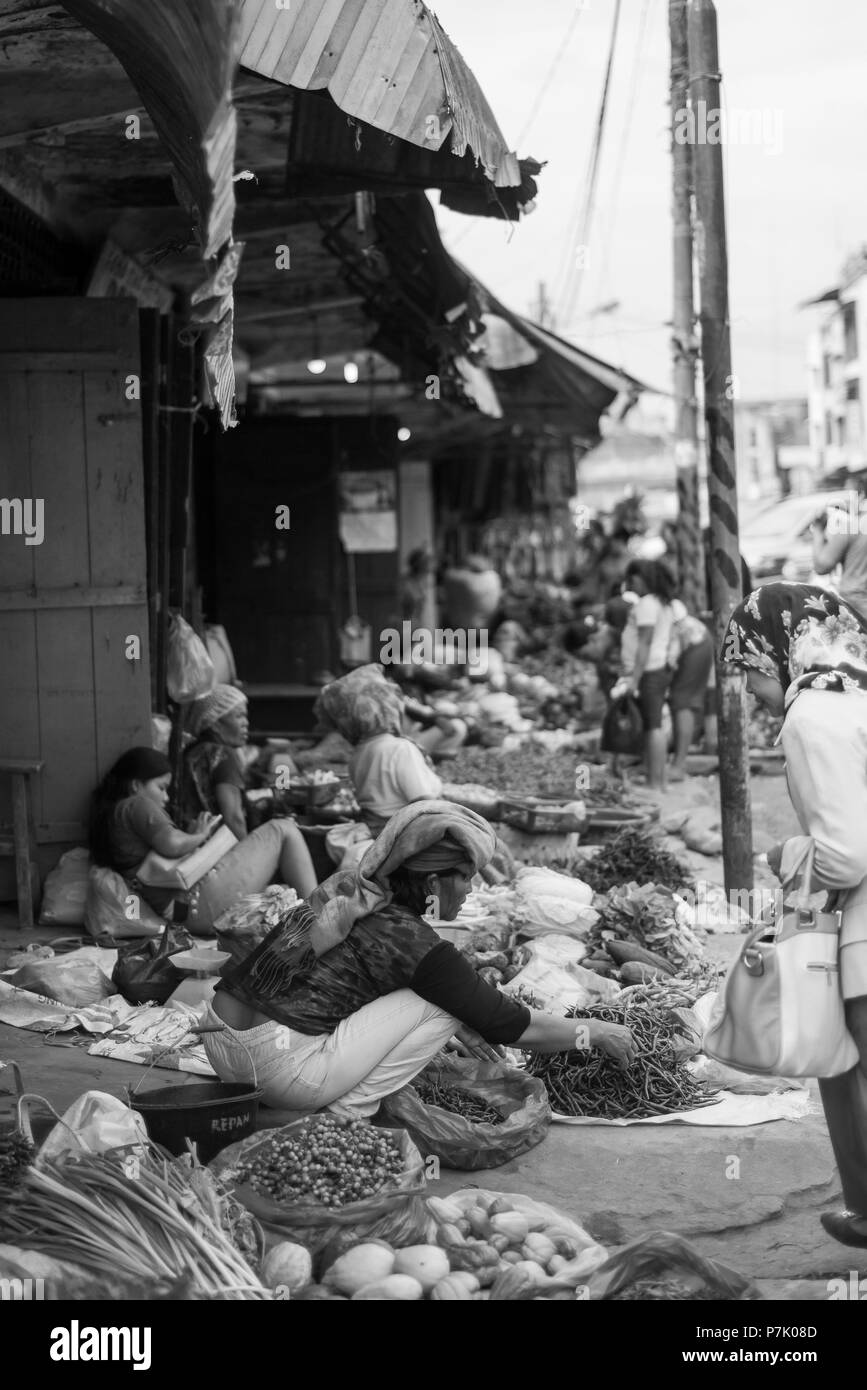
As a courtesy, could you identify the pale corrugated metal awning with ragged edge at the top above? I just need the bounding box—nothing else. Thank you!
[240,0,521,188]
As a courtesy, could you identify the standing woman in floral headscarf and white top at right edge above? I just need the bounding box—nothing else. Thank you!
[721,584,867,1247]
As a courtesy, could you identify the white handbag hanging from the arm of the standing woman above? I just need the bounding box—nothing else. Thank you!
[702,845,859,1079]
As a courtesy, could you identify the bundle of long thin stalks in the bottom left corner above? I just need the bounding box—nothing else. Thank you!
[0,1150,270,1298]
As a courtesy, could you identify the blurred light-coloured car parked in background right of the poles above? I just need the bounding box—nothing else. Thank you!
[741,489,852,588]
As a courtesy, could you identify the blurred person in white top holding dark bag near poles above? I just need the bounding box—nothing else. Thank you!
[611,560,674,791]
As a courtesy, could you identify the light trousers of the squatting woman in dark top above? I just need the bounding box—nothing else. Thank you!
[204,990,459,1119]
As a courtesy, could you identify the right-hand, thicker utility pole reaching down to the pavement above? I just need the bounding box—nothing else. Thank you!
[686,0,753,892]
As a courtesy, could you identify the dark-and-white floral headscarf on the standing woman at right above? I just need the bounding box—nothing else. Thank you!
[721,584,867,709]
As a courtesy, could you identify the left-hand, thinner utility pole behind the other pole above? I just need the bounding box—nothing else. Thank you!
[668,0,707,613]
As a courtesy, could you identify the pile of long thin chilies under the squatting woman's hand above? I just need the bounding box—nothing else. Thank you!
[527,1002,716,1120]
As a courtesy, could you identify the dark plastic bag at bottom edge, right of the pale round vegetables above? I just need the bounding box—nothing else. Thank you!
[589,1230,761,1302]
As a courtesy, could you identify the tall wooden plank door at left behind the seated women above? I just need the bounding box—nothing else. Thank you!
[0,299,150,897]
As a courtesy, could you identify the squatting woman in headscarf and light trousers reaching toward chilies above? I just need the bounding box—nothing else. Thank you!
[204,801,634,1118]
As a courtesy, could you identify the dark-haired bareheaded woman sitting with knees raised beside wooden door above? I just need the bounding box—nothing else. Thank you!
[90,748,317,935]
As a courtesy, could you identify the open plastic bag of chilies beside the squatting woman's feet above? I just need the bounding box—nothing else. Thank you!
[379,1058,550,1172]
